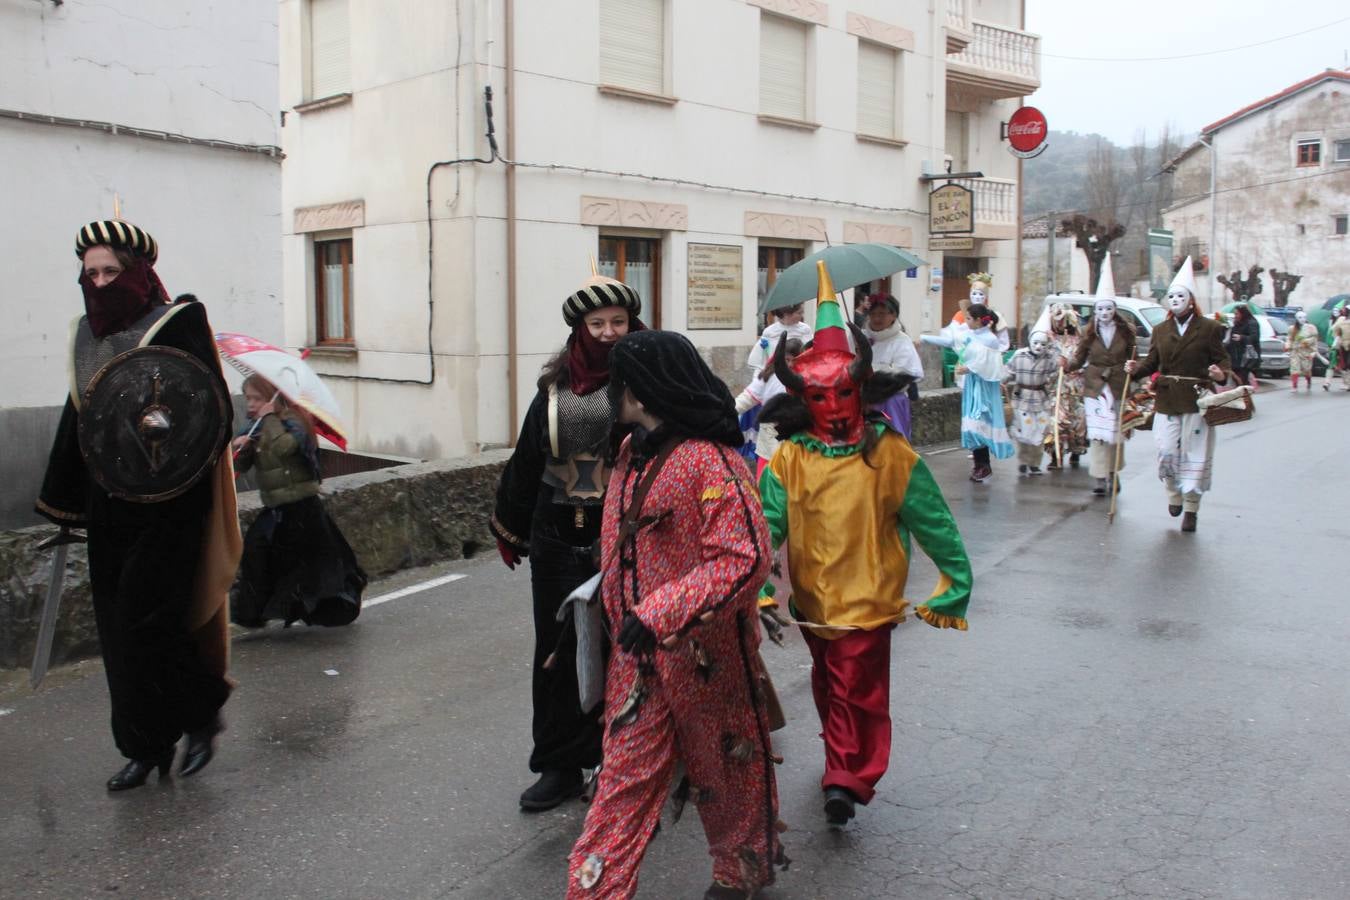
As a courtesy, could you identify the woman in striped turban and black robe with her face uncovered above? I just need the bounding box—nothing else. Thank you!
[489,275,643,812]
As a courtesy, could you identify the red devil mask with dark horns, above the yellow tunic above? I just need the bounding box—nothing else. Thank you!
[774,322,872,444]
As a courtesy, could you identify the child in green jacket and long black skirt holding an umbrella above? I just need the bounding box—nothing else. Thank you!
[230,375,367,627]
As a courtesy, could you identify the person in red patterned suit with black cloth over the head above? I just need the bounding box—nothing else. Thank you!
[567,332,786,900]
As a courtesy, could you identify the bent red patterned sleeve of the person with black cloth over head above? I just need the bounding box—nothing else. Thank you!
[633,451,770,641]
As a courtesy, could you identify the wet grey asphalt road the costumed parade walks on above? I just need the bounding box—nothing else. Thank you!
[0,390,1350,900]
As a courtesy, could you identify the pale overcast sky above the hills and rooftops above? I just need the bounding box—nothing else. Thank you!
[1026,0,1350,144]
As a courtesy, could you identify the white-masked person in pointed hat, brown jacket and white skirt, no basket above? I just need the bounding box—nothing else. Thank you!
[1064,256,1134,497]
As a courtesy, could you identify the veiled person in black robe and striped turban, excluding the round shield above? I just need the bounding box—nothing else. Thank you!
[36,220,242,791]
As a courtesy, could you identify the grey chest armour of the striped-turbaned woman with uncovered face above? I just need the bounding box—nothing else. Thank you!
[544,387,614,506]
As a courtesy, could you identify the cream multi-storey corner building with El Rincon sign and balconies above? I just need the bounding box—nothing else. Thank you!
[271,0,1040,457]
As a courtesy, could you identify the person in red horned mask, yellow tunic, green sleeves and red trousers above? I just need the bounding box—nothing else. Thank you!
[759,262,975,826]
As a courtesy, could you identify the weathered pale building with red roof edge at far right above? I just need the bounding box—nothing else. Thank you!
[1162,69,1350,308]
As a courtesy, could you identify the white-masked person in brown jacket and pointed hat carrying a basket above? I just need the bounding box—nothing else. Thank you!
[1125,256,1233,532]
